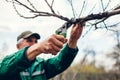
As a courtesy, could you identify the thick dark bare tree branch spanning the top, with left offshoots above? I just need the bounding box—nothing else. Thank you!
[6,0,120,24]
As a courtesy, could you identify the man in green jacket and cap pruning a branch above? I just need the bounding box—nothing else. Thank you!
[0,24,83,80]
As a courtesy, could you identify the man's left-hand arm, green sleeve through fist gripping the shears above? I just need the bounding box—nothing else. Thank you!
[0,35,66,77]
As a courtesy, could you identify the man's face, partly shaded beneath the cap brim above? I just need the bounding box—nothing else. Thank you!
[18,36,37,49]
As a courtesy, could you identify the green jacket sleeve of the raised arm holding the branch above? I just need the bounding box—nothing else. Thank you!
[44,44,78,79]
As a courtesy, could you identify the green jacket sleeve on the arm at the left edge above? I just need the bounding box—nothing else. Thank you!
[0,47,32,77]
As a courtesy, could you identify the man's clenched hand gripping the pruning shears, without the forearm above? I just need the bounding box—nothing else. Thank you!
[40,34,67,55]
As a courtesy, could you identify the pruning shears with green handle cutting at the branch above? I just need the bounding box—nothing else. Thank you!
[55,22,72,38]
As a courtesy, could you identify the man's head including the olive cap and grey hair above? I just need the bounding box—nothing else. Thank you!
[17,31,40,49]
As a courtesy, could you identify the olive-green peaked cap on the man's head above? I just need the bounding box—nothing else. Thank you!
[17,31,40,41]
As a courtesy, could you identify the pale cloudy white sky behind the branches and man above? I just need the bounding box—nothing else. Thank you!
[0,0,120,70]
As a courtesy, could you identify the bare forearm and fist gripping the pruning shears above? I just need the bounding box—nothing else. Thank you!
[27,34,67,60]
